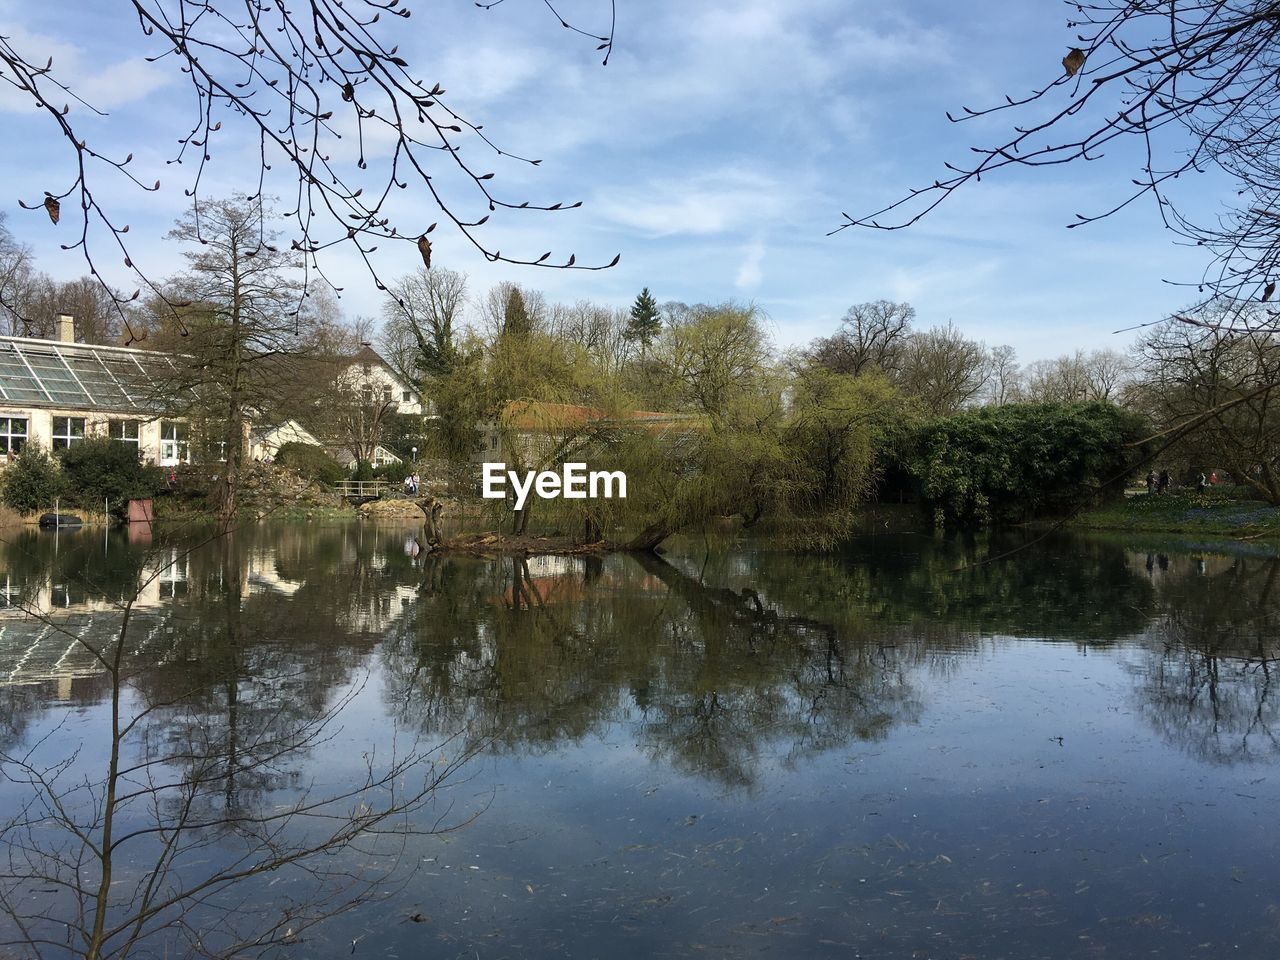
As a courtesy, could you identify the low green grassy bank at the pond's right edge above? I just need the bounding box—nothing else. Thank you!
[1070,489,1280,539]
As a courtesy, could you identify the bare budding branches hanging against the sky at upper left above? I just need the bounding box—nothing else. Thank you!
[0,0,618,343]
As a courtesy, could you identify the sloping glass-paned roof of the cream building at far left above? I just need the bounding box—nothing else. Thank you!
[0,338,175,411]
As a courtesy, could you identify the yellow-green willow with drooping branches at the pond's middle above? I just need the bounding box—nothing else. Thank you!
[481,303,900,550]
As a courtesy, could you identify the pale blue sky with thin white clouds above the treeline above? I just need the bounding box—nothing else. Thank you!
[0,0,1229,362]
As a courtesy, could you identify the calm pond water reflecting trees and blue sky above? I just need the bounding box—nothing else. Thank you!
[0,525,1280,960]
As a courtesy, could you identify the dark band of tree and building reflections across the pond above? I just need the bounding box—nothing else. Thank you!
[0,526,1280,787]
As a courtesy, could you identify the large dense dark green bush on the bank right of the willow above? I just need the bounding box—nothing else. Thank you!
[911,403,1143,526]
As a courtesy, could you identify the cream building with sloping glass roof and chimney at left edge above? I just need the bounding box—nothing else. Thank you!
[0,316,191,466]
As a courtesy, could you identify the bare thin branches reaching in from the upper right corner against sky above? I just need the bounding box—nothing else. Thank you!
[836,0,1280,326]
